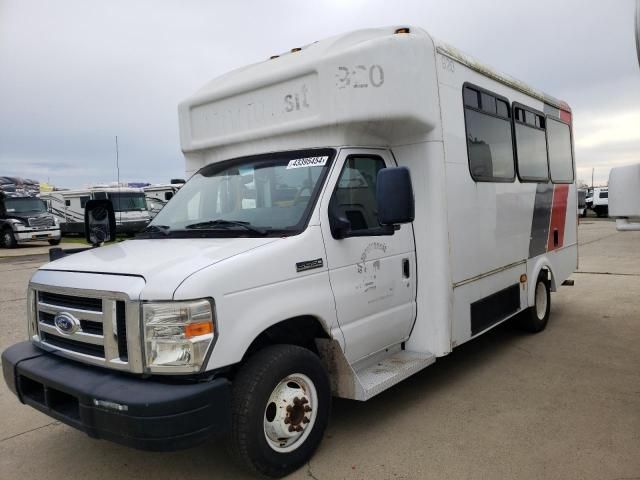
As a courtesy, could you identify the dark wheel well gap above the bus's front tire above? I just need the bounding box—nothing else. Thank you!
[243,315,329,361]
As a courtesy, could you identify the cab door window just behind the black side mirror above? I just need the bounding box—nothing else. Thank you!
[331,155,385,231]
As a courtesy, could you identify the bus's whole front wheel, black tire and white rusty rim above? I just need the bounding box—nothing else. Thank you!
[230,345,331,478]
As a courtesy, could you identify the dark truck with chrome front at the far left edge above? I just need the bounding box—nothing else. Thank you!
[0,192,60,248]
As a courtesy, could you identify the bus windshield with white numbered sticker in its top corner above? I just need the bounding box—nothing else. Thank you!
[148,149,335,236]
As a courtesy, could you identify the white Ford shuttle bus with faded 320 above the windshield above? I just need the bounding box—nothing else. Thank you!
[2,27,578,477]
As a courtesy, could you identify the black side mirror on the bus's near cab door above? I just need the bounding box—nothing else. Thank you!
[376,167,415,226]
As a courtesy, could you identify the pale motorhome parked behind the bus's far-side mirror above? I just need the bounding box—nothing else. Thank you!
[40,186,151,234]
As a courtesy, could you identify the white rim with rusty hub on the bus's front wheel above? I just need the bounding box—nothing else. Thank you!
[263,373,318,453]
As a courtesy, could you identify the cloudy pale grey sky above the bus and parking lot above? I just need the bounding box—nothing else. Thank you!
[0,0,640,187]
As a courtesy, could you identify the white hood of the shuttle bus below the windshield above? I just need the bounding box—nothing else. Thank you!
[41,237,281,298]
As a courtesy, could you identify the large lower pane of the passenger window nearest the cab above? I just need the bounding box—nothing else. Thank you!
[465,108,514,181]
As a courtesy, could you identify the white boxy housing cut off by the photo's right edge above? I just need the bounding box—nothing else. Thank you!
[609,164,640,231]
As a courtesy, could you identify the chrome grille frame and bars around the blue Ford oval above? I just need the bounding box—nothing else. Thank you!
[29,271,144,373]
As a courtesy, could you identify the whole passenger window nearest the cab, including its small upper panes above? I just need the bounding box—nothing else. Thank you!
[465,87,515,182]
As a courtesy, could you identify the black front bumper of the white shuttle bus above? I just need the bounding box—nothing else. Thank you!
[2,342,231,451]
